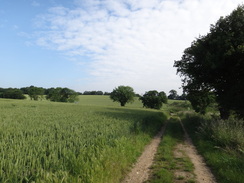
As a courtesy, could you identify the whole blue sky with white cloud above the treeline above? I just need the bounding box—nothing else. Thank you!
[0,0,244,94]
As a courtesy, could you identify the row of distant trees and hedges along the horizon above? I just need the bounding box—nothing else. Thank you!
[0,85,186,106]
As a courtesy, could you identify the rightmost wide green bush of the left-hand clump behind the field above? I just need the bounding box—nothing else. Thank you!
[46,87,79,103]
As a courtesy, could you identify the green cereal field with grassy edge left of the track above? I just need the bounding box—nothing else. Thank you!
[0,96,166,183]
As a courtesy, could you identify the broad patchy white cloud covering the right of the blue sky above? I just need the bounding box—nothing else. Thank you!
[33,0,241,92]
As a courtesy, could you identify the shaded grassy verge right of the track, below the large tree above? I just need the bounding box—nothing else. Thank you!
[182,115,244,183]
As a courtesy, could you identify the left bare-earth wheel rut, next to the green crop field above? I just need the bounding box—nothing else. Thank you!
[122,124,167,183]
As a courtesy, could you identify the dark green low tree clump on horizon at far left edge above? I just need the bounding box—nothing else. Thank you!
[0,88,26,99]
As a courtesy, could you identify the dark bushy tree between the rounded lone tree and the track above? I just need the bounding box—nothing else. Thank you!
[140,90,167,109]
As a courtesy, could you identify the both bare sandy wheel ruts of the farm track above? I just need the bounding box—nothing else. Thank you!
[122,118,216,183]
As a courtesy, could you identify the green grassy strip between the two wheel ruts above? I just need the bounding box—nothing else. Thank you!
[147,118,195,183]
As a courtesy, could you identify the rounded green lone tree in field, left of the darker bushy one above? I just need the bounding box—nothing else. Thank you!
[110,86,135,106]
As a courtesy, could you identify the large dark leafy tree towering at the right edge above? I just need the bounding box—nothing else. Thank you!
[174,5,244,119]
